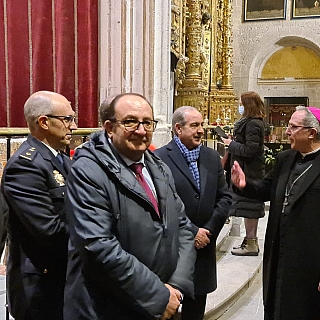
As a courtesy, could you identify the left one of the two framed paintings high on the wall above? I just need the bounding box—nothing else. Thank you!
[243,0,288,21]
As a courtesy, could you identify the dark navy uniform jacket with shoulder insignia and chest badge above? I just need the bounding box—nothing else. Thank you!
[2,135,71,320]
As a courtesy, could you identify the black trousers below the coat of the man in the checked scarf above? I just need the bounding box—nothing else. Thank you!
[181,294,207,320]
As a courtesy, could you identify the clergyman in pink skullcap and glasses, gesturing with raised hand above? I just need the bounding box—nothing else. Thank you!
[232,106,320,320]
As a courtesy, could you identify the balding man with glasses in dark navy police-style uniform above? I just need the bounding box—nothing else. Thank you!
[2,91,77,320]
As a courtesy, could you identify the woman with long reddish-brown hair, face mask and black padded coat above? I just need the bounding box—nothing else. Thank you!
[222,91,265,256]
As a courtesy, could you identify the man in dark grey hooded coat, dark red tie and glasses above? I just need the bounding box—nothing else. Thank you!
[64,93,195,320]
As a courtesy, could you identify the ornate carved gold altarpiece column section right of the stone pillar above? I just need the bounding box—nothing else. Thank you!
[171,0,237,126]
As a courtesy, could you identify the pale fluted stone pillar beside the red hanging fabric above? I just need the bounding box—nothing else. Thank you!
[100,0,173,145]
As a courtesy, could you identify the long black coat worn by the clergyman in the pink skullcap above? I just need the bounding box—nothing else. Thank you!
[242,150,320,320]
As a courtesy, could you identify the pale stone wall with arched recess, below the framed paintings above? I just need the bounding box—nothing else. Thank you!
[232,0,320,108]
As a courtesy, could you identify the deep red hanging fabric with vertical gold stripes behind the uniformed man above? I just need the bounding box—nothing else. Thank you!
[0,0,98,127]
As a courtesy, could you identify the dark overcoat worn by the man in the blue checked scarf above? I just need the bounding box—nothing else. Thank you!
[155,140,232,295]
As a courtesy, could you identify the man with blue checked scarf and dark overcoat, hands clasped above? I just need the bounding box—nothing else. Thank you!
[155,106,231,320]
